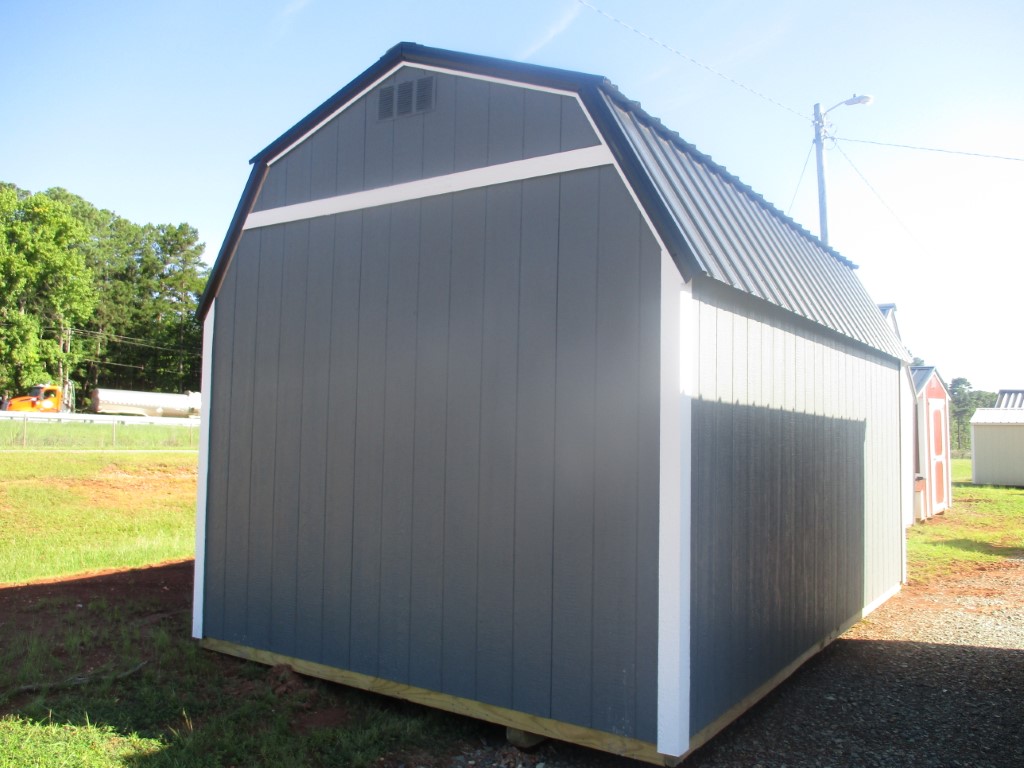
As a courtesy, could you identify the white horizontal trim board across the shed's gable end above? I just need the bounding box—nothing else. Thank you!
[242,144,614,229]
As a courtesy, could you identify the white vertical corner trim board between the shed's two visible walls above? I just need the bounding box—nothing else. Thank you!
[657,250,696,757]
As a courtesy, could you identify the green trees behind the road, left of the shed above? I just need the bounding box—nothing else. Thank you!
[0,182,208,406]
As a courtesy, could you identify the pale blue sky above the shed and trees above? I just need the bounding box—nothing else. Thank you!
[0,0,1024,390]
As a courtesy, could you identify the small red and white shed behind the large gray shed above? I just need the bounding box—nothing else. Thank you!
[910,366,953,520]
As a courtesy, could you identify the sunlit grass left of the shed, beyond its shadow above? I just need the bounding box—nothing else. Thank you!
[0,452,198,584]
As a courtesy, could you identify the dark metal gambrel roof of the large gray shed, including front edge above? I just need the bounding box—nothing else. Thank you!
[200,43,906,359]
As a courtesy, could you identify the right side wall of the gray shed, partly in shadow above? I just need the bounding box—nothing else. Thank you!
[691,290,902,733]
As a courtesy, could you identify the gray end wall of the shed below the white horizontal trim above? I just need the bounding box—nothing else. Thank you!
[205,167,660,741]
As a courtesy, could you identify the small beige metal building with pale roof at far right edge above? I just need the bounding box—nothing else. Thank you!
[971,405,1024,486]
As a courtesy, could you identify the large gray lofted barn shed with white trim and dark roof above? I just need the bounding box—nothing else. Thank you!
[195,43,912,764]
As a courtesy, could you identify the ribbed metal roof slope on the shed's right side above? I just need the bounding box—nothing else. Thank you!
[602,86,905,359]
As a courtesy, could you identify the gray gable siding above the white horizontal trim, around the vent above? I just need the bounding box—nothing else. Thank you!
[253,68,598,211]
